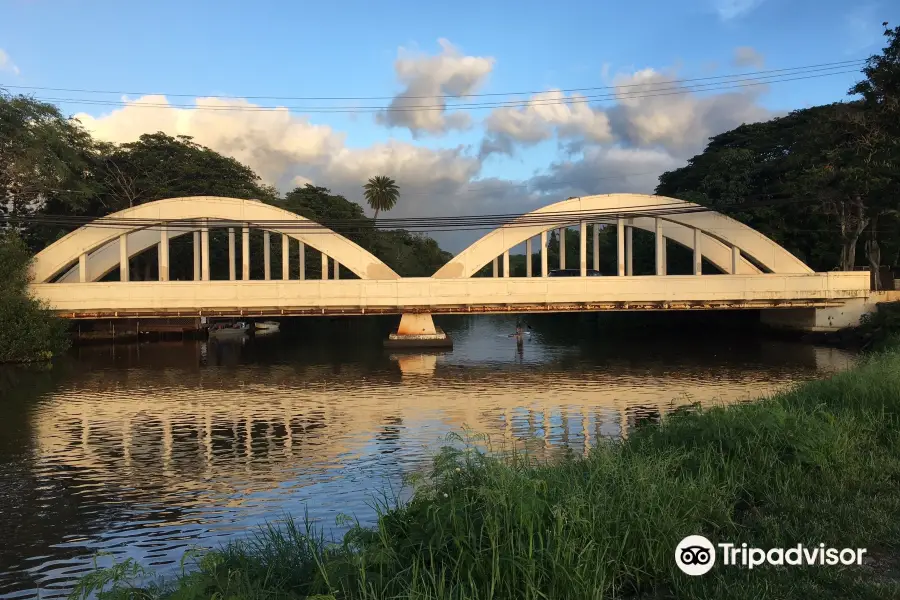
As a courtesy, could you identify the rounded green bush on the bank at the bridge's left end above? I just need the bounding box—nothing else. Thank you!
[0,232,69,363]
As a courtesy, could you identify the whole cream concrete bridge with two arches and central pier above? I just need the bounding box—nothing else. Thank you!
[32,194,869,337]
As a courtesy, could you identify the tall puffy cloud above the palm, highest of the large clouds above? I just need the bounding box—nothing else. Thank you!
[375,39,494,136]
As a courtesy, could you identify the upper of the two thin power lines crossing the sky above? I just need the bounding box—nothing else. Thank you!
[0,59,866,100]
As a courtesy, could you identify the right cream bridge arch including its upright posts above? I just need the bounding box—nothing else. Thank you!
[434,194,813,279]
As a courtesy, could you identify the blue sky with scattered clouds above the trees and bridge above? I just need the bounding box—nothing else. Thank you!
[0,0,900,251]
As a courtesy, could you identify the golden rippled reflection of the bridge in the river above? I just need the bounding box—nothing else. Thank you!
[33,344,849,502]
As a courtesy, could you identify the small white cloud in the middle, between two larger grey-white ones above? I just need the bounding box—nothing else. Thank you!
[480,90,612,156]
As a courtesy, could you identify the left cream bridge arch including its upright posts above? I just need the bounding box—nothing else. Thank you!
[32,196,400,283]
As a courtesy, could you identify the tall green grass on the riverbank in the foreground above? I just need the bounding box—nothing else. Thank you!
[74,351,900,600]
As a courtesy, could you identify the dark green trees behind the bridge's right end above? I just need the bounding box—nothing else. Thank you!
[656,28,900,270]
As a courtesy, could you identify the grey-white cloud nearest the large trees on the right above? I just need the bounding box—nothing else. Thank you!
[607,69,772,157]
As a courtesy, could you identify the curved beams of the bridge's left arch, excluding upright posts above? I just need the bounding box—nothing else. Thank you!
[32,196,400,283]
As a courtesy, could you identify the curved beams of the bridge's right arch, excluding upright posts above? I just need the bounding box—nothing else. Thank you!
[434,194,813,279]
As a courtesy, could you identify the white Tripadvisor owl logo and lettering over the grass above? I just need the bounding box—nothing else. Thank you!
[675,535,866,575]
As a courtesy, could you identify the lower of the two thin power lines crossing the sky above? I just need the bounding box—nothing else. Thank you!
[5,65,857,113]
